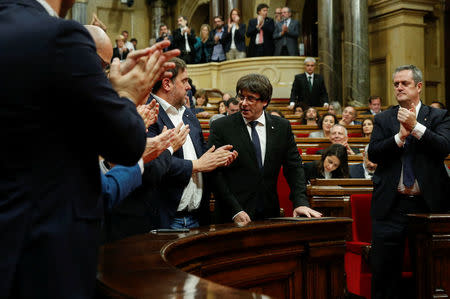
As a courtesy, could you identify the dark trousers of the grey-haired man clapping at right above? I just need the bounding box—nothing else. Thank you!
[370,194,428,299]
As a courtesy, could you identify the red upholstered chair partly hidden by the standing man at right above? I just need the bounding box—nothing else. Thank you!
[345,194,412,299]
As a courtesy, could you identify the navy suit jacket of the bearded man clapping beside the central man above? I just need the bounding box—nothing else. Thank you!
[148,99,209,228]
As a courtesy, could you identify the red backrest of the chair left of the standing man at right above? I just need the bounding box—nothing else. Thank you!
[350,194,372,243]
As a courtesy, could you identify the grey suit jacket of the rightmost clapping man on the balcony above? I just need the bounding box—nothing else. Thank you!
[273,19,300,56]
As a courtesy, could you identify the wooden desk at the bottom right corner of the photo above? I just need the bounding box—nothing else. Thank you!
[409,214,450,299]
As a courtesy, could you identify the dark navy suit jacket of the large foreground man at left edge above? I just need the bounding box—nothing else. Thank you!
[0,0,145,298]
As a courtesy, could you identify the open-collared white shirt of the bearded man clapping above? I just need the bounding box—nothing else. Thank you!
[153,95,203,211]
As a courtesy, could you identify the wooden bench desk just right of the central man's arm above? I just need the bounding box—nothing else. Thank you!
[306,179,373,218]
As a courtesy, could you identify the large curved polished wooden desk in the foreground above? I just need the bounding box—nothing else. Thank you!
[97,218,351,299]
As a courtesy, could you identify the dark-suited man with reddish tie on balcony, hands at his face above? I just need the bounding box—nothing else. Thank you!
[247,3,275,57]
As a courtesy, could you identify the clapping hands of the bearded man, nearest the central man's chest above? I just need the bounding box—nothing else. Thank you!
[192,145,237,173]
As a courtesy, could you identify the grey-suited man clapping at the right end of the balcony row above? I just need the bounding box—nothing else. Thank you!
[273,7,300,56]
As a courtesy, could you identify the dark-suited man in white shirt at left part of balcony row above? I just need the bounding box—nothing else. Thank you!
[172,16,197,64]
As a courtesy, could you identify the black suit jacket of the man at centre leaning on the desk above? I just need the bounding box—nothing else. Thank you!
[208,113,309,222]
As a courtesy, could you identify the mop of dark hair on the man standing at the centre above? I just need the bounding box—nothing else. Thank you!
[236,74,272,107]
